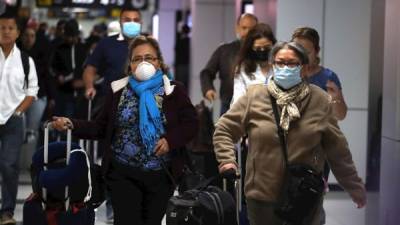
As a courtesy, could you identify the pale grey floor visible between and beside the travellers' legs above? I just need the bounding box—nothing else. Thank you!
[1,175,378,225]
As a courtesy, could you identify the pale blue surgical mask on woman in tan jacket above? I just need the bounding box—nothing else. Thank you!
[274,66,302,90]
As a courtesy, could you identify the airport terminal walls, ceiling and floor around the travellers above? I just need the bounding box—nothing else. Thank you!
[0,0,400,225]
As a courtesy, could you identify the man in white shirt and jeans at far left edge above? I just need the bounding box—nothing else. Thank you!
[0,11,39,225]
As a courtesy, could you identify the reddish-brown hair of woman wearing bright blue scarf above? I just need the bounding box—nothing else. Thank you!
[125,35,169,76]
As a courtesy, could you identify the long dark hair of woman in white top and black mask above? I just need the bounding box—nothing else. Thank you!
[234,23,276,78]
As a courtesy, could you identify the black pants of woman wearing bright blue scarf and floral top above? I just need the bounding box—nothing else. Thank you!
[107,161,174,225]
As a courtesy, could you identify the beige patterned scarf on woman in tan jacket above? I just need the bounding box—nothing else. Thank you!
[267,79,310,131]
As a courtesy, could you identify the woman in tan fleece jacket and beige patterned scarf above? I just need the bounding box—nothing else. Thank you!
[214,42,366,225]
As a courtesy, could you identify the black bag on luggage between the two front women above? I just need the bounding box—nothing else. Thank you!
[166,178,237,225]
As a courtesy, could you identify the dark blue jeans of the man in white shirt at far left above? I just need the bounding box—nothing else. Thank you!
[0,116,24,214]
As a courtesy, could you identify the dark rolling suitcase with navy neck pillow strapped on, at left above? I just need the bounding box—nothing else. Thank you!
[23,123,95,225]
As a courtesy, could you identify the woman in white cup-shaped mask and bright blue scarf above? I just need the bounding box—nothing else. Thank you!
[53,36,198,225]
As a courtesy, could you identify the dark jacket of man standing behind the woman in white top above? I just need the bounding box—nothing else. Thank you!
[200,40,240,103]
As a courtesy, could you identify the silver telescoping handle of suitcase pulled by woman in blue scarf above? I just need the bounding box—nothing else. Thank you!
[42,122,72,210]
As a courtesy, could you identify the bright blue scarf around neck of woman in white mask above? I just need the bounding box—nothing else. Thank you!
[129,70,164,155]
